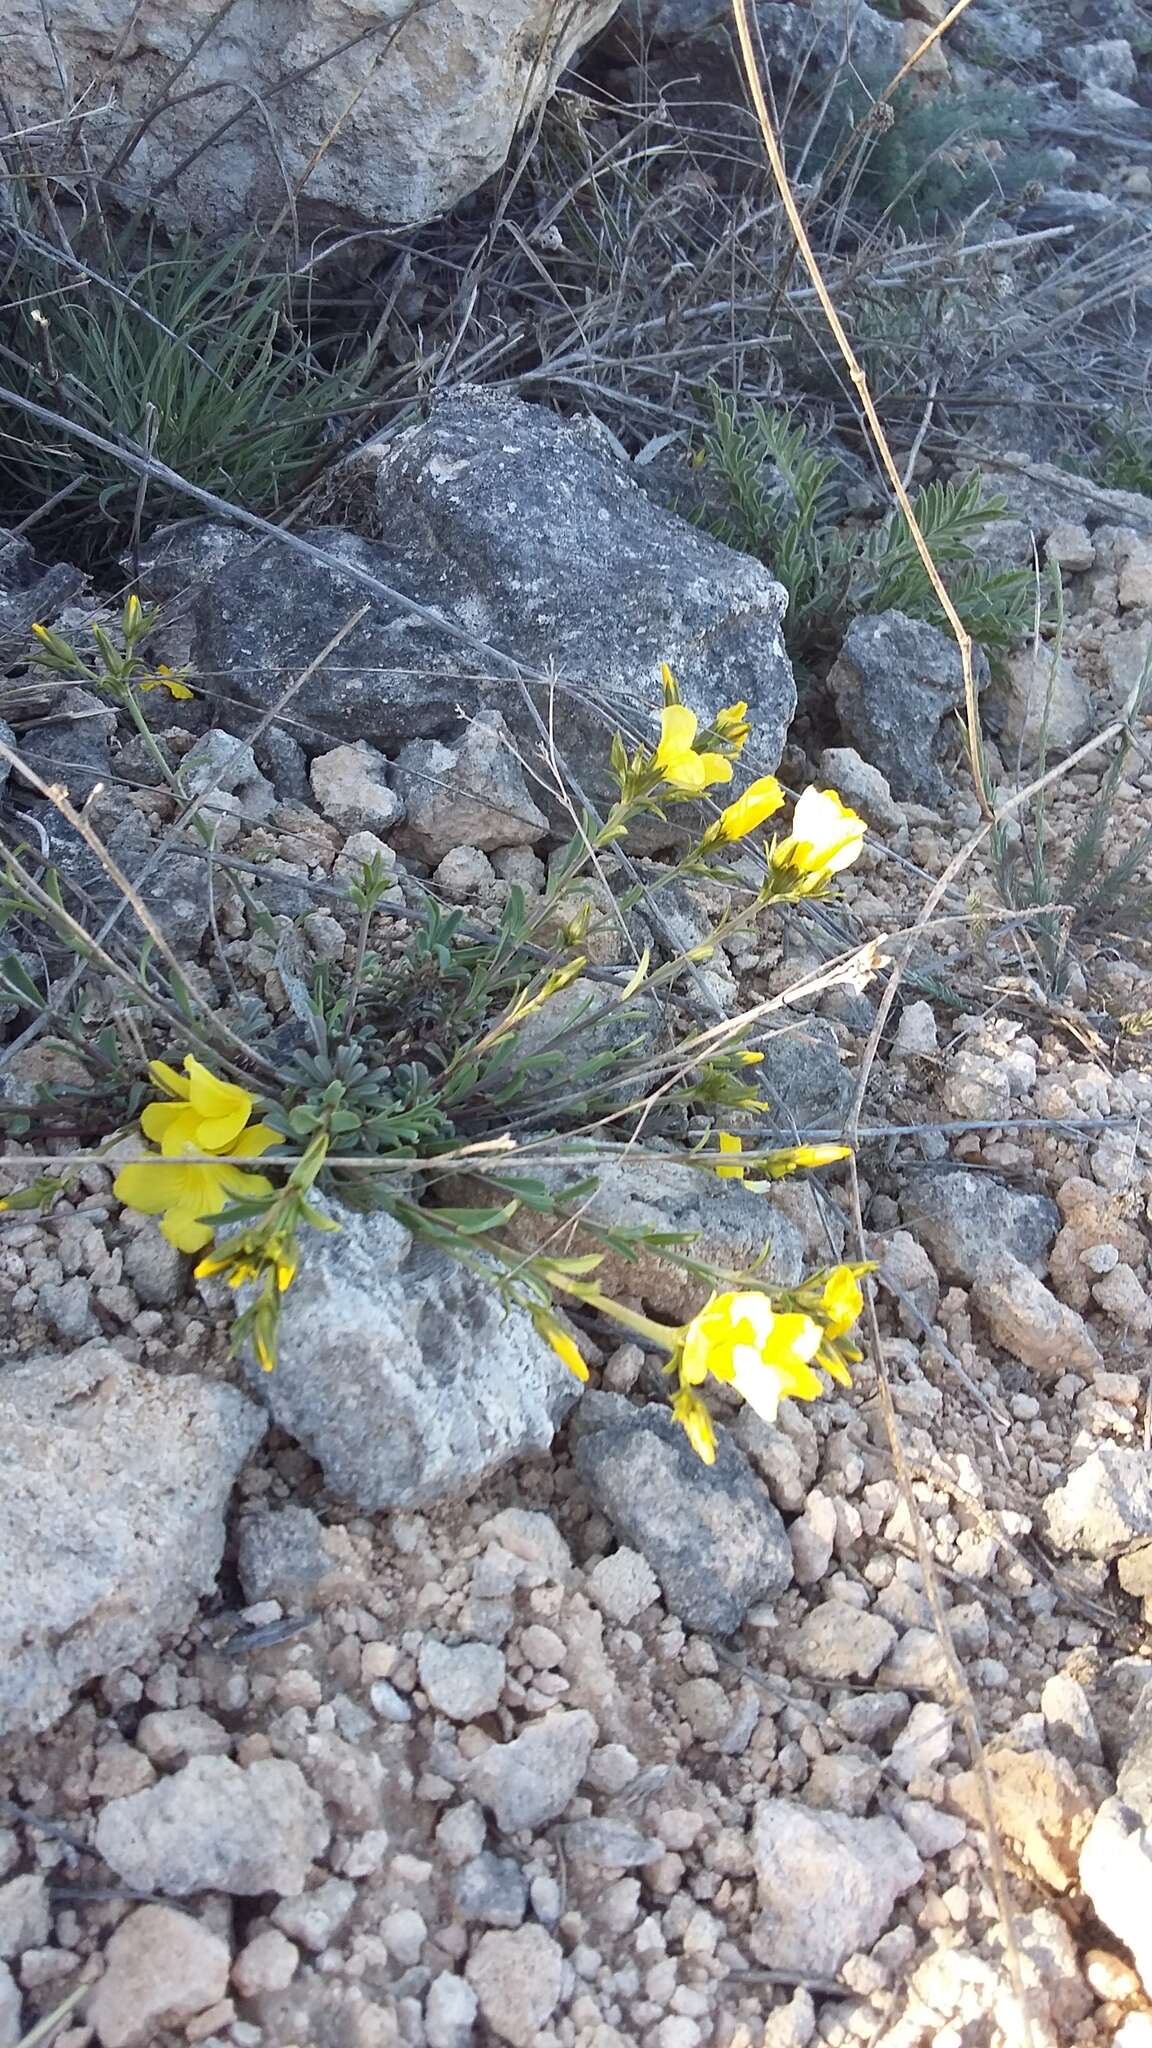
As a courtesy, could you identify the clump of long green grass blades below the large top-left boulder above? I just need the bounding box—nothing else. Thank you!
[0,229,371,561]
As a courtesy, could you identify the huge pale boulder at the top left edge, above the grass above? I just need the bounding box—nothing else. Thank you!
[4,0,615,231]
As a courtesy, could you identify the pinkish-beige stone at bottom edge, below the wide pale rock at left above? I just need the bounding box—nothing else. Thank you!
[88,1905,228,2048]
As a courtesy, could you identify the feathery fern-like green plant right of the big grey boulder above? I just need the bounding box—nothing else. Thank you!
[703,389,1035,668]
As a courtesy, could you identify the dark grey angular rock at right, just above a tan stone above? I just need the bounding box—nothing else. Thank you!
[900,1167,1060,1286]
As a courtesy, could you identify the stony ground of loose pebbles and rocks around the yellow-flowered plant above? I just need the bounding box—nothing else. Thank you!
[0,419,1152,2048]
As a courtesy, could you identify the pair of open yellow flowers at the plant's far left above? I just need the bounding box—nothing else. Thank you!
[113,1053,281,1251]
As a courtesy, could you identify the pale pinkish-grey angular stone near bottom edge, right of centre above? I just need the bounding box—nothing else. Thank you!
[752,1798,922,1976]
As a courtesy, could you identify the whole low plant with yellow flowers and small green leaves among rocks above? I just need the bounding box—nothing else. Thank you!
[0,622,865,1458]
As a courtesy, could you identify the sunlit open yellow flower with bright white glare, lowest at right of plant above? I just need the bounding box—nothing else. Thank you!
[681,1290,824,1421]
